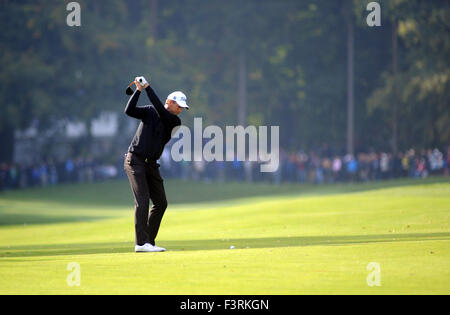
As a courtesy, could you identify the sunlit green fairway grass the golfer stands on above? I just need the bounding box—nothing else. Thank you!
[0,178,450,294]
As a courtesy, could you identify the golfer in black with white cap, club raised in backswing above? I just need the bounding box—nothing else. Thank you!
[124,77,189,252]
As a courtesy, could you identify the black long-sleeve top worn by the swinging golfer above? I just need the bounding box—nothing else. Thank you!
[125,86,181,161]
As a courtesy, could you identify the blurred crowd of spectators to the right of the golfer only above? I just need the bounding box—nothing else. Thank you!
[161,147,450,184]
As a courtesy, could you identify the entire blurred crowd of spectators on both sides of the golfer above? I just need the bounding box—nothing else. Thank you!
[0,147,450,191]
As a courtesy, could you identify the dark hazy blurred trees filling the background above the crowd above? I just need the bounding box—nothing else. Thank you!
[0,0,450,186]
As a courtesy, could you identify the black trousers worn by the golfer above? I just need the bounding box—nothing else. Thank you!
[124,153,167,246]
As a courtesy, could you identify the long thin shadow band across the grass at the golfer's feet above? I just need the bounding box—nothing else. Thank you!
[0,233,450,261]
